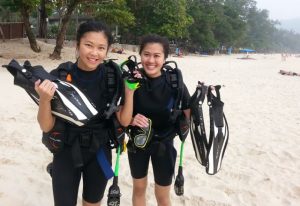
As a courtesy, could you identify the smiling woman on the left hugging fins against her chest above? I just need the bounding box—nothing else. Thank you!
[35,21,131,206]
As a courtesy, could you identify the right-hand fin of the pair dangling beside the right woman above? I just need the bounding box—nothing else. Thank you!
[206,85,229,175]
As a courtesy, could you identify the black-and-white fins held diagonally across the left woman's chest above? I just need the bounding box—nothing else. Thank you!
[3,59,98,126]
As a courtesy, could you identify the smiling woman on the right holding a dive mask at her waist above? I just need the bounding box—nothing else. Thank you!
[123,34,190,206]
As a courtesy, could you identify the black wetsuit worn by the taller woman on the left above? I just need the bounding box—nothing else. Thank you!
[51,64,117,206]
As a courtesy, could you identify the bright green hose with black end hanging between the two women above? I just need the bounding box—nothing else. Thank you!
[107,145,121,206]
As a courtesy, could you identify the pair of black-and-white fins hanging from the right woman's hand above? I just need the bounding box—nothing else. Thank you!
[190,82,229,175]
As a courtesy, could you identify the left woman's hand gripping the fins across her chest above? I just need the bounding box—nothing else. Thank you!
[34,79,56,102]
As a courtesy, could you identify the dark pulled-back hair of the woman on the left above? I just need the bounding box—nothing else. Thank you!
[76,20,113,47]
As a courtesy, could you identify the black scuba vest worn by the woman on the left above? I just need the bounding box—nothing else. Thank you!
[42,60,125,153]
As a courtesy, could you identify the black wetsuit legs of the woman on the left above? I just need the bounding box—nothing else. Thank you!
[52,147,111,206]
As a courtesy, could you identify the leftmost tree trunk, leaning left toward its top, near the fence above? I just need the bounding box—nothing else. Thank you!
[21,5,41,52]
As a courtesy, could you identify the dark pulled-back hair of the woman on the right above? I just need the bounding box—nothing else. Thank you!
[139,34,169,59]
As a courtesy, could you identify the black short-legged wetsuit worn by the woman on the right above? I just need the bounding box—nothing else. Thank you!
[128,72,190,186]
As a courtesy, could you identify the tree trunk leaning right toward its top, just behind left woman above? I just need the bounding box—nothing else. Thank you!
[49,0,80,59]
